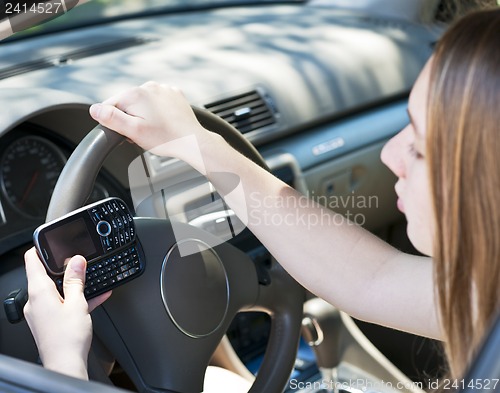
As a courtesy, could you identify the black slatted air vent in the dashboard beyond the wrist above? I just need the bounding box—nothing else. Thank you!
[205,90,277,134]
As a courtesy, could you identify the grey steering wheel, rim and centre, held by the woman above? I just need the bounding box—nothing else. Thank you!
[47,108,304,393]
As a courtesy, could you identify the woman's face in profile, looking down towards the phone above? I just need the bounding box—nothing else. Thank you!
[381,61,434,255]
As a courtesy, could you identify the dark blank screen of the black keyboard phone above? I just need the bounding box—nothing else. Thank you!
[45,218,97,270]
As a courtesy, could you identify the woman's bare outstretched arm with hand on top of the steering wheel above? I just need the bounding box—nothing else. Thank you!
[90,82,441,338]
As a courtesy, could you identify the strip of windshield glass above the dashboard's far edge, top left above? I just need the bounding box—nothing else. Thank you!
[0,0,304,40]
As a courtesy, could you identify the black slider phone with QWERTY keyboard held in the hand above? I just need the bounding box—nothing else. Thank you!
[33,198,145,299]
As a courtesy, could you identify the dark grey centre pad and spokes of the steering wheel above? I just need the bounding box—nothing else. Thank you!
[94,219,259,392]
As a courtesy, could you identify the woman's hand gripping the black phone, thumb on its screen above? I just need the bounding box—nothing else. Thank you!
[24,247,111,379]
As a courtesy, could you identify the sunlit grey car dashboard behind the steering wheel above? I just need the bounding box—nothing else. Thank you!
[0,3,440,392]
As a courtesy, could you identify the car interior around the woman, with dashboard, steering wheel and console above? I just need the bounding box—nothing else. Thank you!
[0,0,476,393]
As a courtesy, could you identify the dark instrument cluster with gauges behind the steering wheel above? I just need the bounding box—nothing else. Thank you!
[0,123,115,255]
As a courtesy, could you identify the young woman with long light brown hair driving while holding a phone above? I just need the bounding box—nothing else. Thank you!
[26,9,500,377]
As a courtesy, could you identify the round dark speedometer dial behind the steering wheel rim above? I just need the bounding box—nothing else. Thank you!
[0,136,66,218]
